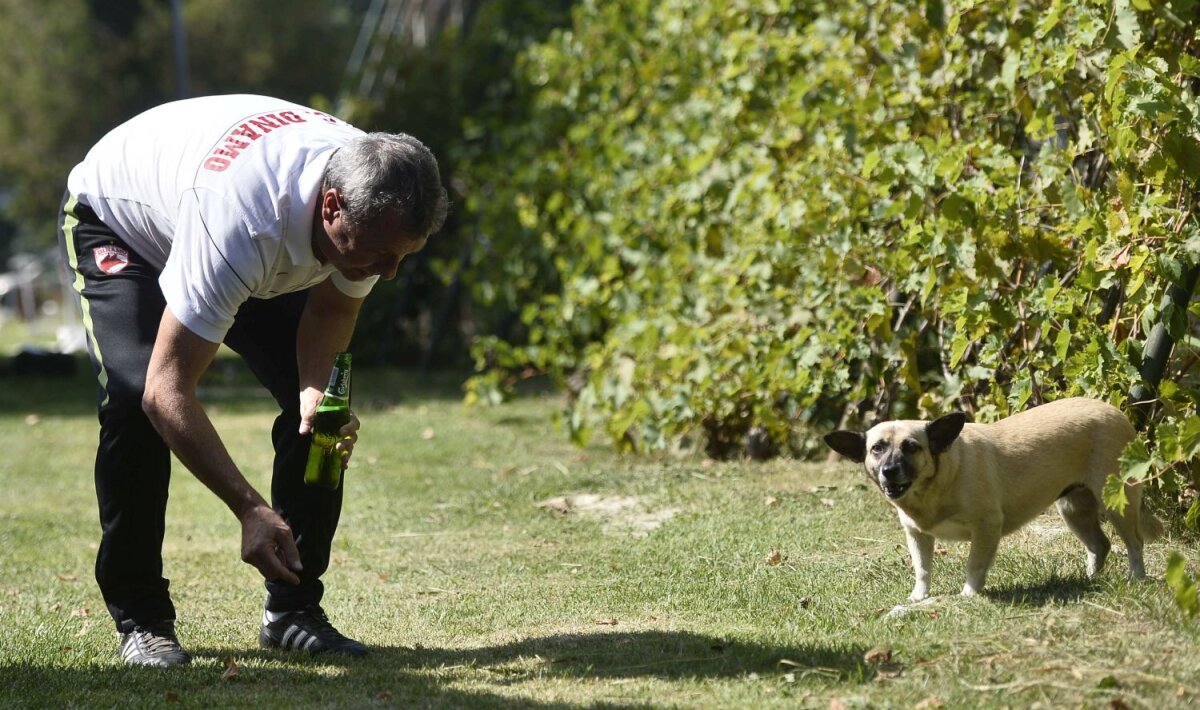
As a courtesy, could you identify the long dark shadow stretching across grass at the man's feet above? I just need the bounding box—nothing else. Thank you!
[0,631,874,708]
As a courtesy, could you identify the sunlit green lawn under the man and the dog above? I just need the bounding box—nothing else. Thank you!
[0,357,1200,708]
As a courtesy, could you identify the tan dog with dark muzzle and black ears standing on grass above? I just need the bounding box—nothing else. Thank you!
[824,397,1163,602]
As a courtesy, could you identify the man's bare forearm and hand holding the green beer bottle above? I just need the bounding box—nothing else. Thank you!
[296,279,362,443]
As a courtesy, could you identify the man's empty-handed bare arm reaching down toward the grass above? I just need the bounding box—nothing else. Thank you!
[142,307,300,584]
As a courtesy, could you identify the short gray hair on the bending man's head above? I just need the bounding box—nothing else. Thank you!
[323,133,449,239]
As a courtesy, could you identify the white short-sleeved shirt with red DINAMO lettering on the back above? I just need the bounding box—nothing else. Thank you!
[67,95,378,343]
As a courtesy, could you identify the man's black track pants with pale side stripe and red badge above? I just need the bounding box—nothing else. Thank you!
[59,195,342,631]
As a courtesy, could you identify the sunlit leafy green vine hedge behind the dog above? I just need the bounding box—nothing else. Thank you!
[460,0,1200,508]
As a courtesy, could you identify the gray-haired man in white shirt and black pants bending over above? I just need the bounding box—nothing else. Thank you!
[59,96,446,666]
